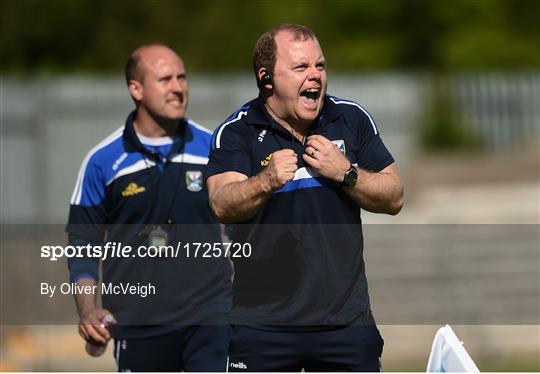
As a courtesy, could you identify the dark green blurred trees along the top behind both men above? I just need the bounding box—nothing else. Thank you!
[0,0,540,73]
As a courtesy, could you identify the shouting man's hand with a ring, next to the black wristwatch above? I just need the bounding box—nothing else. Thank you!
[302,135,351,183]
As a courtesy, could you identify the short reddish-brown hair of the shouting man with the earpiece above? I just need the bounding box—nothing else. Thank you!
[253,23,316,82]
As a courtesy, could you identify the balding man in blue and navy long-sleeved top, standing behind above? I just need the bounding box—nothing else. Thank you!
[67,44,231,371]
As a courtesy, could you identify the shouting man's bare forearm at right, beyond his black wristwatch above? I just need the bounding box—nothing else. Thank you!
[344,169,403,215]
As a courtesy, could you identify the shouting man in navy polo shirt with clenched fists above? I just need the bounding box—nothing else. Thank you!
[207,24,403,371]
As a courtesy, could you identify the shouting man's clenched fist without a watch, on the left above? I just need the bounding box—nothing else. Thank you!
[261,149,298,191]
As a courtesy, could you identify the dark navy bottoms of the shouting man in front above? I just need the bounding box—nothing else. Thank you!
[229,325,384,372]
